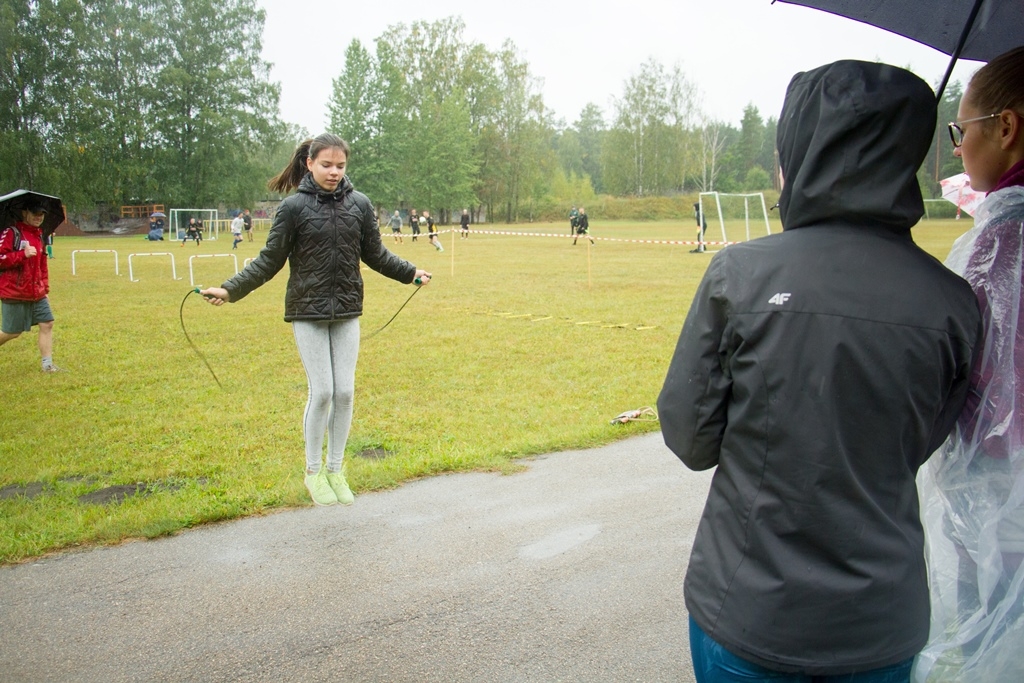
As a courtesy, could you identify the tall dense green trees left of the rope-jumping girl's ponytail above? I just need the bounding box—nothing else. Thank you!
[0,0,288,218]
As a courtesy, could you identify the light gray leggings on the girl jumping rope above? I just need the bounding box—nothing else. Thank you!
[292,317,359,472]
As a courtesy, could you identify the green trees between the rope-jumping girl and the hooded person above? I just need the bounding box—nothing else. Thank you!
[330,17,776,222]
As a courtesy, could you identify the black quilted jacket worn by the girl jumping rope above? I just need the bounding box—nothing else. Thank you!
[222,174,416,323]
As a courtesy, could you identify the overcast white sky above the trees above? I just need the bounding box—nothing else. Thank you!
[258,0,981,134]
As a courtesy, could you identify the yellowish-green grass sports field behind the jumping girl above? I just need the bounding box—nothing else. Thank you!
[0,220,969,563]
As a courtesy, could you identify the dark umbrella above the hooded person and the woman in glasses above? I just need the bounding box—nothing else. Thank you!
[772,0,1024,98]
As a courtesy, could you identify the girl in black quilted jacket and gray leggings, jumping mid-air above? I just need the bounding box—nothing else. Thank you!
[201,133,430,505]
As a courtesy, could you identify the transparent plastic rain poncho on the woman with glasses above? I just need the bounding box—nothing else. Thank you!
[917,186,1024,683]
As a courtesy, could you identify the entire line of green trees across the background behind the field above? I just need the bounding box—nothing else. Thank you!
[0,5,961,222]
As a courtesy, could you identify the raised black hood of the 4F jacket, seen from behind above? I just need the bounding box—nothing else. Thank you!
[777,60,937,232]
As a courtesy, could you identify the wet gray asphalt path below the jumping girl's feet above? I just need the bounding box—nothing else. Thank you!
[0,433,711,683]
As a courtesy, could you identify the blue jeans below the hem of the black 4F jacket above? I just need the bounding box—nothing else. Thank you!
[690,616,913,683]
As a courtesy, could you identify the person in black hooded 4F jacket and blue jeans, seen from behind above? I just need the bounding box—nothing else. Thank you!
[657,61,981,683]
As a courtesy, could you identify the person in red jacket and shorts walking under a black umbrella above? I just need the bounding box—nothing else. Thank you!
[0,198,60,373]
